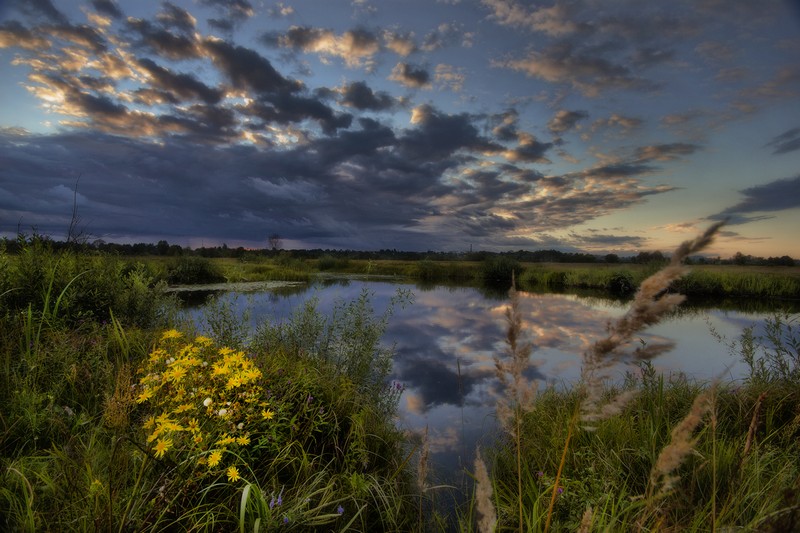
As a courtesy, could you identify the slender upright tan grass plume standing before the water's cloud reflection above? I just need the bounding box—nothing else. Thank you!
[494,276,537,435]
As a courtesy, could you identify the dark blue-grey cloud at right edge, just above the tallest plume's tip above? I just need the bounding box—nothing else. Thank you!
[709,174,800,225]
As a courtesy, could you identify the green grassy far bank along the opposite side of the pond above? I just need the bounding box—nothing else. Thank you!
[125,252,800,299]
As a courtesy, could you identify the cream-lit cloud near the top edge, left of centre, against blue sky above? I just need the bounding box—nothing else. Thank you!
[261,26,380,67]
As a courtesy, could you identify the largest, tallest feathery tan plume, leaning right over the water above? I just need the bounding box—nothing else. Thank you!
[581,221,725,429]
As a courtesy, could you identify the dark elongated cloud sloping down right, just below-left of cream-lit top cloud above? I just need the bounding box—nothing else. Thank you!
[202,39,301,93]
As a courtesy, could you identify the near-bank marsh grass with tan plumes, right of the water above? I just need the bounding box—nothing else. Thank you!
[472,223,800,531]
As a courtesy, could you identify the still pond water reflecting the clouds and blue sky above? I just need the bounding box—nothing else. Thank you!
[187,279,792,485]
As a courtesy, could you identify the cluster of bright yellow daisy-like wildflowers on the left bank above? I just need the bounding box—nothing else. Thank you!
[136,330,276,482]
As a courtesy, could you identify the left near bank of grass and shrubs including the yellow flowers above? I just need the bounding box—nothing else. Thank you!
[0,241,419,531]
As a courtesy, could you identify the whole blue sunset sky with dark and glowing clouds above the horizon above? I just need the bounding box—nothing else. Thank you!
[0,0,800,257]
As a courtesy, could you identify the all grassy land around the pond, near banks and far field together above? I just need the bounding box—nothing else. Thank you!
[0,237,800,532]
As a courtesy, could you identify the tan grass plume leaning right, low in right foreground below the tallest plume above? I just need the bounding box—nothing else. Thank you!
[650,382,717,498]
